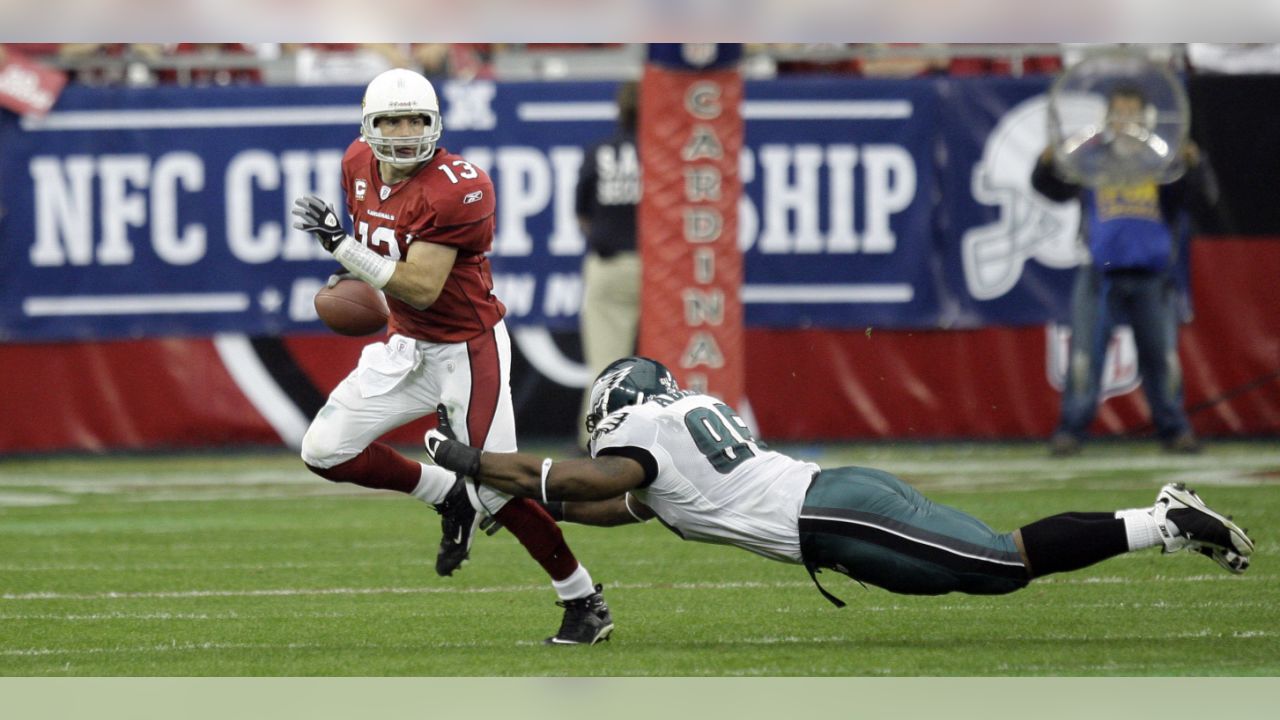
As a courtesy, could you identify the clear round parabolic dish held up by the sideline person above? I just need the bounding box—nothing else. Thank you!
[1048,50,1190,187]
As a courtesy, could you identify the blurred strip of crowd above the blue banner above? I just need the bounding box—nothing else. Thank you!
[0,42,1280,86]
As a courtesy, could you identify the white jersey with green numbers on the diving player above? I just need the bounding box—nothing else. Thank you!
[591,391,818,562]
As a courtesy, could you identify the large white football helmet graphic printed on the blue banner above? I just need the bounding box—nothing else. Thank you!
[960,95,1083,300]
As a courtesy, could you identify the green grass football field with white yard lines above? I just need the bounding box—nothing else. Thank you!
[0,443,1280,676]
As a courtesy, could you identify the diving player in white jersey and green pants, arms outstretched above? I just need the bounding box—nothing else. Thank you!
[426,357,1253,605]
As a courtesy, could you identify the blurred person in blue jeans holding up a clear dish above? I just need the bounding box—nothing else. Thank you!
[1032,85,1217,456]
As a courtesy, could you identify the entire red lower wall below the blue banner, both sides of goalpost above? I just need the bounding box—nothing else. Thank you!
[0,238,1280,455]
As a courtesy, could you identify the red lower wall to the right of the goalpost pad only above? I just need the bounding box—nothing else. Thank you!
[746,237,1280,441]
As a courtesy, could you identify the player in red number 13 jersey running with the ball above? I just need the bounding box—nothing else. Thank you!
[293,69,613,644]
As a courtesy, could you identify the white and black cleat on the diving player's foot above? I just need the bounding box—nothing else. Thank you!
[1152,483,1253,574]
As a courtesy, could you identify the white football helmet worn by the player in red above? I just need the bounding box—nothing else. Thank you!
[360,68,444,165]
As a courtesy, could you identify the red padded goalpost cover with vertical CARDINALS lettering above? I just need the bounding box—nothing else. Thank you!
[639,65,744,404]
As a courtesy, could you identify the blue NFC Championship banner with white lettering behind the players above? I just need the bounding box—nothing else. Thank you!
[0,78,1076,341]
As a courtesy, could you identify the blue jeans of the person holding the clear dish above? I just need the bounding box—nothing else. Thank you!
[1059,265,1190,439]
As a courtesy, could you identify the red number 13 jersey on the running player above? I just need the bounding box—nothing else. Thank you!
[342,140,507,342]
